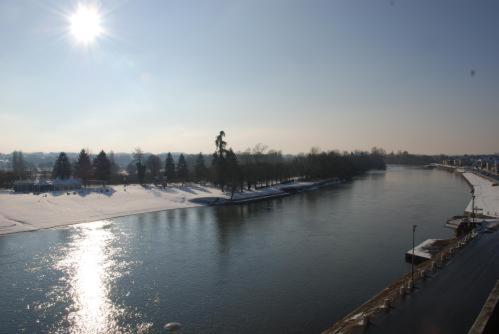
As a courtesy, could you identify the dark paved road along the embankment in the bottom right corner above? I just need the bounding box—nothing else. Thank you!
[366,231,499,334]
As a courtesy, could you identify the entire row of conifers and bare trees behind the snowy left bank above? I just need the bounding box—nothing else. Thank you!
[0,131,385,193]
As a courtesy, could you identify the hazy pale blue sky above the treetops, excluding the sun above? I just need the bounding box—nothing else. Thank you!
[0,0,499,153]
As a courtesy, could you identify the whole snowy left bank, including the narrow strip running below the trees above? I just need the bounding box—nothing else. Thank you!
[0,179,344,237]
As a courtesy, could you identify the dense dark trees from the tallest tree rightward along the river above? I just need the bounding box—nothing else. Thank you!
[211,131,386,194]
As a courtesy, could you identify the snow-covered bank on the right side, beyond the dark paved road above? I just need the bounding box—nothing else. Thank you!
[463,172,499,218]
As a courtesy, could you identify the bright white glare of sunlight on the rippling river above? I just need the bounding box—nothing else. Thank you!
[54,221,123,333]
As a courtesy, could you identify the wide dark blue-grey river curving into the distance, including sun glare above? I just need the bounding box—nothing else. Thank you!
[0,166,470,333]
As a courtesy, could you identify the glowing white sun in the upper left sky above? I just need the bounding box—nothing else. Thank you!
[69,4,104,45]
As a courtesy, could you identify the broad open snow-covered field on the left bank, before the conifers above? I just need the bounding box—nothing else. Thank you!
[0,185,226,234]
